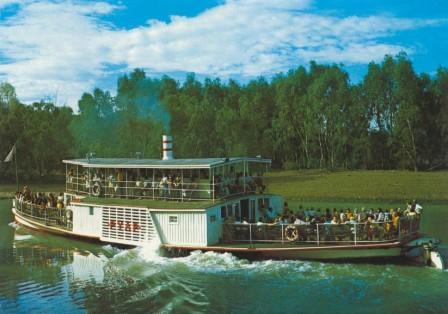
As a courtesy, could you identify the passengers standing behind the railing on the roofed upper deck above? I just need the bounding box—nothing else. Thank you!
[67,169,266,199]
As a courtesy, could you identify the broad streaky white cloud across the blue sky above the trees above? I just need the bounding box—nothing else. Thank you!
[0,0,444,107]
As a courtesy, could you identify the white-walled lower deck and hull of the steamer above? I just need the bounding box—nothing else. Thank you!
[9,196,420,260]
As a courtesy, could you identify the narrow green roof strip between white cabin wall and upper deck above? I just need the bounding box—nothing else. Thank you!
[82,197,213,209]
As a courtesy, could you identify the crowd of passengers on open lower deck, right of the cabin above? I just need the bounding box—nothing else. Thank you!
[225,201,423,241]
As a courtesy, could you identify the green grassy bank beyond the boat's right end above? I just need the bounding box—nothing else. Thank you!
[266,170,448,202]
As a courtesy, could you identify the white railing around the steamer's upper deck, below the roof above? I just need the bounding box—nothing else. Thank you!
[66,176,265,201]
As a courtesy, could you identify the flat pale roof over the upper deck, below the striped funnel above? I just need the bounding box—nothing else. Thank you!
[63,157,271,169]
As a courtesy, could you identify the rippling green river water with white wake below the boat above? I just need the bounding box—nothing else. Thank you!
[0,200,448,313]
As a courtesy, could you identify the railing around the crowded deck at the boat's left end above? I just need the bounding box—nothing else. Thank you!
[14,198,73,230]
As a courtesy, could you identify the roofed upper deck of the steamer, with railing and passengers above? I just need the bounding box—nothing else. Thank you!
[63,157,271,202]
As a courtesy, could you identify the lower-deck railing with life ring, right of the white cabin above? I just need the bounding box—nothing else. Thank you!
[223,217,420,246]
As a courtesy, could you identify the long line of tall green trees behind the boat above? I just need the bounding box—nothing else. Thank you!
[0,54,448,180]
